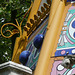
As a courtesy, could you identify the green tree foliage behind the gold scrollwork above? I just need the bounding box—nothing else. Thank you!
[0,0,31,64]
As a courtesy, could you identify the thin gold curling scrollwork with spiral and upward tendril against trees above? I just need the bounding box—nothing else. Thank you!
[1,2,33,38]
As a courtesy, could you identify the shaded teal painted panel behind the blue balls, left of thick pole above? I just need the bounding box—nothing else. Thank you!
[26,17,49,71]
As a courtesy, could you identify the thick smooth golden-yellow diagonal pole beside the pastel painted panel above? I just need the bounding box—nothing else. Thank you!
[34,0,65,75]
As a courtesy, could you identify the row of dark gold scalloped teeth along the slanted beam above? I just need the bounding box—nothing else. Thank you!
[24,0,51,36]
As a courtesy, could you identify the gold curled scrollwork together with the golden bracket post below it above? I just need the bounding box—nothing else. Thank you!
[1,2,33,63]
